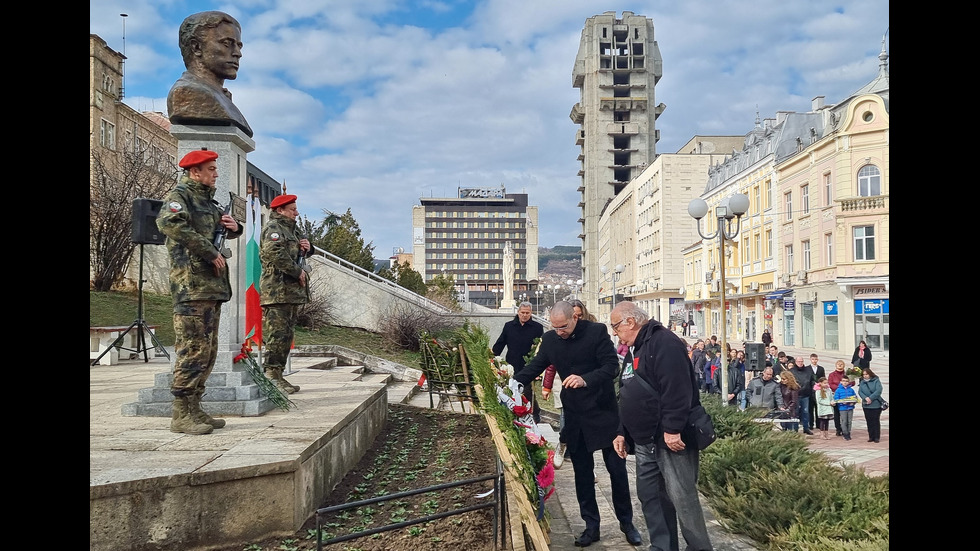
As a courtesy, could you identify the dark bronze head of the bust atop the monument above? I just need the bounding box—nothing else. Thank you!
[178,11,242,85]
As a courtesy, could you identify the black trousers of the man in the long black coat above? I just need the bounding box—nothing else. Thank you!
[568,441,633,531]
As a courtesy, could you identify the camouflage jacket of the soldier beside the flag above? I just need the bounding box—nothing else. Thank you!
[259,211,313,305]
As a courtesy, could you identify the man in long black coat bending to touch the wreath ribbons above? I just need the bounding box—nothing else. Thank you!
[514,301,644,547]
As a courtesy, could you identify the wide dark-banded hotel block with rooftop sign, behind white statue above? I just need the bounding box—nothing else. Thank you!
[412,186,538,307]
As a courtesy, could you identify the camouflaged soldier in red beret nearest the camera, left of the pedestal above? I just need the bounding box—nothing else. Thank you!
[157,149,244,434]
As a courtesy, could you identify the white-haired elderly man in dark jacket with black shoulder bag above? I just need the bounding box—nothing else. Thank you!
[609,301,712,551]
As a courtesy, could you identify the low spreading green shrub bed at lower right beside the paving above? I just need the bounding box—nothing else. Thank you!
[698,395,889,551]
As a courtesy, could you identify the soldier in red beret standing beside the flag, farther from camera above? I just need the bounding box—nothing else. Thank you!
[259,195,313,394]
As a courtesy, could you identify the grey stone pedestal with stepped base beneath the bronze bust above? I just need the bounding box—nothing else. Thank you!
[123,124,275,416]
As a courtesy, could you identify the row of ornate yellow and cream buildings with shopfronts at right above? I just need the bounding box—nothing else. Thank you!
[684,42,890,354]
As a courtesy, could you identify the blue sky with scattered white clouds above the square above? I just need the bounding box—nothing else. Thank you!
[89,0,891,254]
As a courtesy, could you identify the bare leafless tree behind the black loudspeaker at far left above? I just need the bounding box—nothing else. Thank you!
[89,140,178,291]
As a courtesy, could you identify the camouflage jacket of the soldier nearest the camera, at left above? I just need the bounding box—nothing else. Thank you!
[157,175,245,306]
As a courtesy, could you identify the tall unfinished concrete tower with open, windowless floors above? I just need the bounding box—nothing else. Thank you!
[569,11,665,314]
